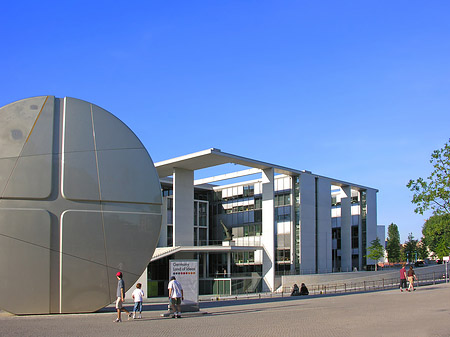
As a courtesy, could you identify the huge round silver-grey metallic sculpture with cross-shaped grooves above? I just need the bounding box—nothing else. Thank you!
[0,96,162,314]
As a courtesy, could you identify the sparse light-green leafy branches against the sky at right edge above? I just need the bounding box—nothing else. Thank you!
[406,139,450,215]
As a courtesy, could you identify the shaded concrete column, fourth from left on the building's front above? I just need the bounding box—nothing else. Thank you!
[316,177,333,274]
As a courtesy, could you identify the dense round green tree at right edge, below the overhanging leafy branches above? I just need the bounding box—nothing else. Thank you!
[422,214,450,258]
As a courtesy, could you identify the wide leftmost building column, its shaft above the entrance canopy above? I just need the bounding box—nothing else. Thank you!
[173,168,194,246]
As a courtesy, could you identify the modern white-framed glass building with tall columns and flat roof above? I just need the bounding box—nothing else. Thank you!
[142,149,378,296]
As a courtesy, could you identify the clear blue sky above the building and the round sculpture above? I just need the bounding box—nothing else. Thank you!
[0,0,450,241]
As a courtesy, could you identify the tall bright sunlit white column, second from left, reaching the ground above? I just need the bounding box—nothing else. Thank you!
[261,168,275,291]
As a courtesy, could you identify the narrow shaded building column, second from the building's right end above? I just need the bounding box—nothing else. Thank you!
[341,186,352,271]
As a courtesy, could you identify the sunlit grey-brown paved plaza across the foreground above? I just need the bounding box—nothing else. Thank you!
[0,284,450,337]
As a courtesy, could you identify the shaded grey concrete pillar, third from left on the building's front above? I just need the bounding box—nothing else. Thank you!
[300,173,316,274]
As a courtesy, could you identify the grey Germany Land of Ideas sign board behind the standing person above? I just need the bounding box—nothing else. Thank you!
[169,260,199,311]
